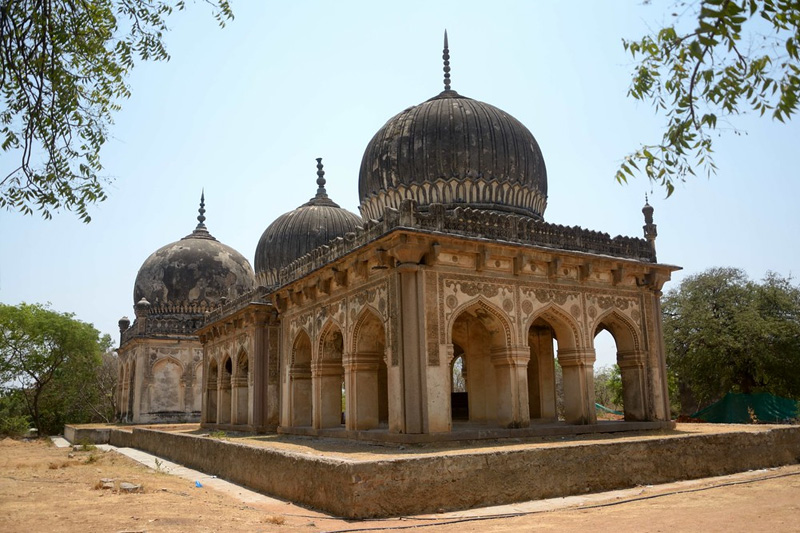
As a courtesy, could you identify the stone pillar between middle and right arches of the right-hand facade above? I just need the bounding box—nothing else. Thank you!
[558,349,597,424]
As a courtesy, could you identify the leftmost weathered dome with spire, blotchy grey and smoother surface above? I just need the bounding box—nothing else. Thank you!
[133,200,255,307]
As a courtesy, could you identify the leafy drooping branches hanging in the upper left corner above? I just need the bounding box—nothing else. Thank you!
[0,0,233,222]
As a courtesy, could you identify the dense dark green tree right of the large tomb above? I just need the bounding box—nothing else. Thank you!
[663,268,800,414]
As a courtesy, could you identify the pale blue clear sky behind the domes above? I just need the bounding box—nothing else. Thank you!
[0,0,800,365]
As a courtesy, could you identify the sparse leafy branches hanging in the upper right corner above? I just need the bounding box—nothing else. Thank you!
[616,0,800,196]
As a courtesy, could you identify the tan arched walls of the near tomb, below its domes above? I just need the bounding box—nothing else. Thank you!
[200,231,672,438]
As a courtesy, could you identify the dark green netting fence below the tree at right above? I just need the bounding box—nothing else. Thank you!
[691,392,799,424]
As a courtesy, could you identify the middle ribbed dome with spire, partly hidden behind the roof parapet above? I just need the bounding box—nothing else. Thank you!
[255,158,363,275]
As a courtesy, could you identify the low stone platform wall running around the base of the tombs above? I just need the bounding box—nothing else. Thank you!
[103,426,800,518]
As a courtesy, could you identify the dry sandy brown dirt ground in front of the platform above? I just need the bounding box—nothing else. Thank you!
[0,439,800,533]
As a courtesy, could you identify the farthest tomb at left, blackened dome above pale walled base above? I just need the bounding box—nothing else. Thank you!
[118,197,254,423]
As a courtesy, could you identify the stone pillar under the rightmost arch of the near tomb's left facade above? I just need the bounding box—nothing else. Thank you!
[343,352,381,430]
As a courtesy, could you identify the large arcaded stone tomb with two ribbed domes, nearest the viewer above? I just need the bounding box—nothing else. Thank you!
[121,41,676,440]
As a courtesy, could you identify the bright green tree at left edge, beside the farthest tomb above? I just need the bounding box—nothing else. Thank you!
[0,303,110,434]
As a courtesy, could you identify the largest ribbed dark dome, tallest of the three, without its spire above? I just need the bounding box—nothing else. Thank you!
[358,90,547,219]
